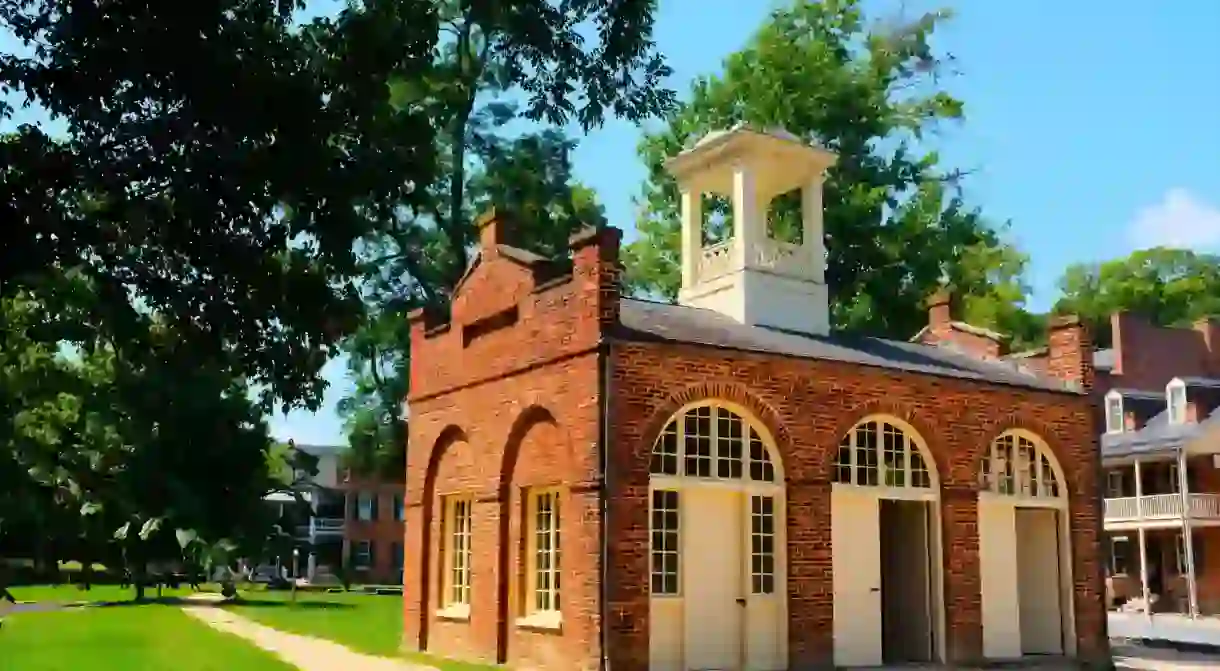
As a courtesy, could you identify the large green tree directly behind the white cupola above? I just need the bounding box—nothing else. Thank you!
[625,0,1026,338]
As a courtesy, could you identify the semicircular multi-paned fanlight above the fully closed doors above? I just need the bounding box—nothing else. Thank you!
[651,405,776,482]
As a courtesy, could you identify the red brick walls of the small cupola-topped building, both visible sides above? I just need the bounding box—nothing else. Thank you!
[404,222,1108,671]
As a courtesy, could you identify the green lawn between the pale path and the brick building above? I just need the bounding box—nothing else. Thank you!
[226,592,504,671]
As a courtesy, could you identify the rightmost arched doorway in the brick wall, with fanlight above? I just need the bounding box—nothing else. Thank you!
[978,429,1075,659]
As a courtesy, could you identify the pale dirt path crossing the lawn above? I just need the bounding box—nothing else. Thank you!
[182,599,437,671]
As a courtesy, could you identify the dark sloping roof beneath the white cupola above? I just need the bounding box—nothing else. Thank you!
[617,298,1072,392]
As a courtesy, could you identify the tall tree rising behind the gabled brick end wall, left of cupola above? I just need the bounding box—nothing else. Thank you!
[340,0,673,477]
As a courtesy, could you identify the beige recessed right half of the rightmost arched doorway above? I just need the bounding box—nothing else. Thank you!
[1016,508,1064,655]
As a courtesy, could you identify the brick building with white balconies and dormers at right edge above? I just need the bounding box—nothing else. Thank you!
[1054,314,1220,615]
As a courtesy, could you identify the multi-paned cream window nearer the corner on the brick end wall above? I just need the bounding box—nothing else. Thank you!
[517,488,565,628]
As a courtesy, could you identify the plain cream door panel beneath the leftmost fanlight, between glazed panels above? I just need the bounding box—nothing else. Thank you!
[682,487,745,671]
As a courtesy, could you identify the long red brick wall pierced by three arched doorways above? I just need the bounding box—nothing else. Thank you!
[609,344,1108,671]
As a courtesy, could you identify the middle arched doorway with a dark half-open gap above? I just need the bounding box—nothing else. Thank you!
[831,416,944,666]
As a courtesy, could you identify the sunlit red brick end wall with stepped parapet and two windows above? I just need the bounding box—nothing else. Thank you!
[404,222,619,671]
